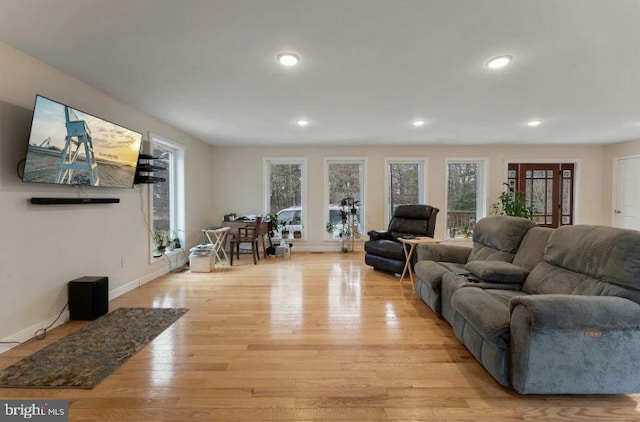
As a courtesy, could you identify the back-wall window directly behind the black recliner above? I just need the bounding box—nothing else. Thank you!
[385,158,426,221]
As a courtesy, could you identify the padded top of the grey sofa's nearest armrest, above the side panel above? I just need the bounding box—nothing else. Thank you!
[509,294,640,330]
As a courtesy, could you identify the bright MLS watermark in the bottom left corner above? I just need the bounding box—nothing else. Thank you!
[0,400,69,422]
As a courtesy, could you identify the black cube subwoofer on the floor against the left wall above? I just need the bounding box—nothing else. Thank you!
[69,276,109,321]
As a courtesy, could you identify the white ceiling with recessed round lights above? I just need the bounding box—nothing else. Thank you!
[0,0,640,145]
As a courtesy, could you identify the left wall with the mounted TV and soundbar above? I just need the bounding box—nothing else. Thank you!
[0,43,212,340]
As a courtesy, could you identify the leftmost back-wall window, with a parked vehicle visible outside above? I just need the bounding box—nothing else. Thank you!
[264,158,306,237]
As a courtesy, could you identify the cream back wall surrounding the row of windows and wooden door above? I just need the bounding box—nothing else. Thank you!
[211,145,608,250]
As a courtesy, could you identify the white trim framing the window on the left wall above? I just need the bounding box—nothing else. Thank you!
[147,132,182,263]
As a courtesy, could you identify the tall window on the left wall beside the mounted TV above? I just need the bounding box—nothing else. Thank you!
[149,134,186,256]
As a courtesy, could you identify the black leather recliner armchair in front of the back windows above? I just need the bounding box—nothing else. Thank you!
[364,205,440,274]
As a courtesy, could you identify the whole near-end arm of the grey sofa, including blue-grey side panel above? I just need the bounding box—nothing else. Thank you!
[509,294,640,394]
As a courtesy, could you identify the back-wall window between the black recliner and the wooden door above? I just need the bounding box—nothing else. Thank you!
[447,160,486,238]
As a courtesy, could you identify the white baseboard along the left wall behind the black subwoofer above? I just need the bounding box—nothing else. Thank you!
[0,257,187,354]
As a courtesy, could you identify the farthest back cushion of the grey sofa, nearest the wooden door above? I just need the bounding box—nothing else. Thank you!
[469,215,536,262]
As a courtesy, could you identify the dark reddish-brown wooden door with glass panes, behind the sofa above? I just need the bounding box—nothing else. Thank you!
[508,163,574,228]
